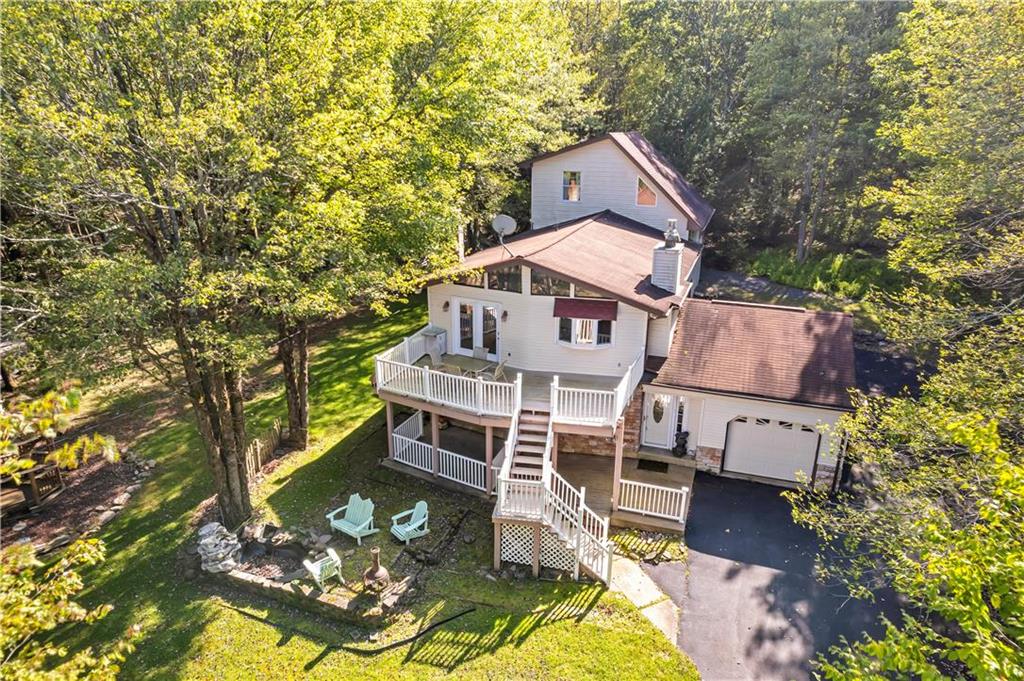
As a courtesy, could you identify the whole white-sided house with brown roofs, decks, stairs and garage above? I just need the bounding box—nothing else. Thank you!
[374,132,854,581]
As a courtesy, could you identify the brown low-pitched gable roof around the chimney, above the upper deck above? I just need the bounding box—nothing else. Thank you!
[444,211,700,316]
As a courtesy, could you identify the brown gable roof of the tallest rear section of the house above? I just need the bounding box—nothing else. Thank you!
[520,131,715,230]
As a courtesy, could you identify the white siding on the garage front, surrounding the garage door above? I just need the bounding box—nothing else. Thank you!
[646,386,841,465]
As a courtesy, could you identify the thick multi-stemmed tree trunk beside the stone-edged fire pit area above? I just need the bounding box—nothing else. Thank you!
[175,320,252,529]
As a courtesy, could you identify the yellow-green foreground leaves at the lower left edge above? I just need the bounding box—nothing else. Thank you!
[0,390,132,681]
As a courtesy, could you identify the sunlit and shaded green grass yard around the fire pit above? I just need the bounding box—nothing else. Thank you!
[66,304,697,679]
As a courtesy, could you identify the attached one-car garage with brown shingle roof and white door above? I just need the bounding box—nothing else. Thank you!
[642,298,856,488]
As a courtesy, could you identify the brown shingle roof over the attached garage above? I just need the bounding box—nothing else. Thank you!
[652,298,856,409]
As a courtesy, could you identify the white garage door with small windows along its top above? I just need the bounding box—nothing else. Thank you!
[723,417,818,482]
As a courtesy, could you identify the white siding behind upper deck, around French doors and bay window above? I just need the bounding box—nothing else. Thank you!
[427,267,647,376]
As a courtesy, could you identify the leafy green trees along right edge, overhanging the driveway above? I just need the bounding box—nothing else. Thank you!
[791,2,1024,679]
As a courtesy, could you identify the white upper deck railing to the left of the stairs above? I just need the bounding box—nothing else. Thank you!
[374,337,517,417]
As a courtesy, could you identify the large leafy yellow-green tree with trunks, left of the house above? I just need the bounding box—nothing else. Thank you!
[2,2,578,525]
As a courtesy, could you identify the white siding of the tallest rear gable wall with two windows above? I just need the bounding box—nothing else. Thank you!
[530,139,687,235]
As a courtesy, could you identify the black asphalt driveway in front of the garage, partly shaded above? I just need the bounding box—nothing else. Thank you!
[645,473,896,681]
